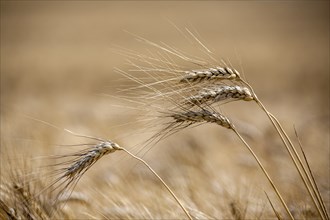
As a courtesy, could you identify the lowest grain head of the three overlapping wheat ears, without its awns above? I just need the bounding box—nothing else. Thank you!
[170,109,232,128]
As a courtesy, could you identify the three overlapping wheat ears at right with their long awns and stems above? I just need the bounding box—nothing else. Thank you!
[112,30,329,219]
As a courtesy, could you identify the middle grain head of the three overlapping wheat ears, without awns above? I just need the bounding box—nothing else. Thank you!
[185,85,254,105]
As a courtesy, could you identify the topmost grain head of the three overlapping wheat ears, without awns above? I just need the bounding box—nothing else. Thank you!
[180,67,240,83]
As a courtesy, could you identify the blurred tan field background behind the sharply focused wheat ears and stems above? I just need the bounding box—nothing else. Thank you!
[1,1,330,219]
